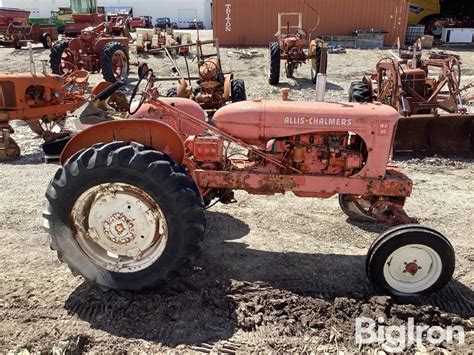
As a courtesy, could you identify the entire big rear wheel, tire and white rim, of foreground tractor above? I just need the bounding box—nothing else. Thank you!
[44,142,205,290]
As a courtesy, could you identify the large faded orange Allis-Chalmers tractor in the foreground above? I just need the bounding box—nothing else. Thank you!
[44,70,454,296]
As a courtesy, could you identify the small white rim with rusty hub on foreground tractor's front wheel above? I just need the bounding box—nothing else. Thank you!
[383,244,442,293]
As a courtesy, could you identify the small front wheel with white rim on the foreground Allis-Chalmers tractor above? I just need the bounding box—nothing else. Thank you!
[366,224,455,297]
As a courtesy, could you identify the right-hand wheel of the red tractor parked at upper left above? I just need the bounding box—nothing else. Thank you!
[100,42,130,83]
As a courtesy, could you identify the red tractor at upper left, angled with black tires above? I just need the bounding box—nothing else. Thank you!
[50,23,129,83]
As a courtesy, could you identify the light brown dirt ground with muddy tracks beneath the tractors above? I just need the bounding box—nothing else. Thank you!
[0,32,474,354]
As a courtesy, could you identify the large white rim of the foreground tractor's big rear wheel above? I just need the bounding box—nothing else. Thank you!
[71,183,168,273]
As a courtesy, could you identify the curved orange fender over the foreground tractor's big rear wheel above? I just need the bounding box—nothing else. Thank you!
[60,119,184,165]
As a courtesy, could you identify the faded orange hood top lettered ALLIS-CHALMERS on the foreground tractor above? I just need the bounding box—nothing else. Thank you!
[213,100,399,145]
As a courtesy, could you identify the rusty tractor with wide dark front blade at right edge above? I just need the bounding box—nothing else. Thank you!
[349,45,474,155]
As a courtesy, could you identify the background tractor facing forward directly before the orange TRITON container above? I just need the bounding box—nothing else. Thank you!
[268,13,327,85]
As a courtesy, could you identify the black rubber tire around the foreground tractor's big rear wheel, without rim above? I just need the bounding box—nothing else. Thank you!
[43,142,206,291]
